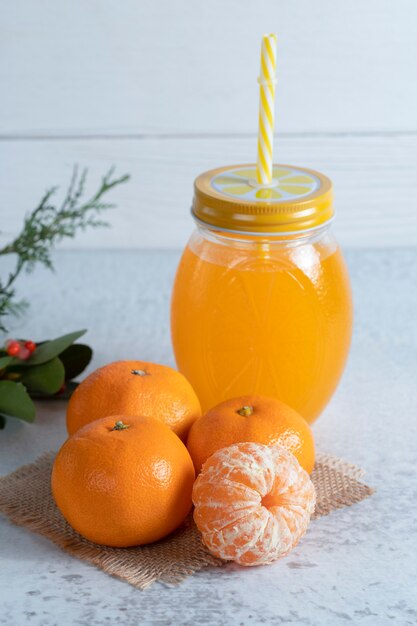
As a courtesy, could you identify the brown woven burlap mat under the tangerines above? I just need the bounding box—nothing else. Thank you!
[0,452,373,589]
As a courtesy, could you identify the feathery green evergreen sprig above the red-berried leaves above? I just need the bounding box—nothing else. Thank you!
[0,166,129,331]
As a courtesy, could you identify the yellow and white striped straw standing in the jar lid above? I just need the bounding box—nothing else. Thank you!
[256,35,277,185]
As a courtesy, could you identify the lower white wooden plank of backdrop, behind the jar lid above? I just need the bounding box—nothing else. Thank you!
[0,135,417,248]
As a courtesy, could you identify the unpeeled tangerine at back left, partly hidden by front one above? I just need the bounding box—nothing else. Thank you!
[67,361,201,440]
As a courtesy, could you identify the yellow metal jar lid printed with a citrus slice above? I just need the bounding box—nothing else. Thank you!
[192,164,334,234]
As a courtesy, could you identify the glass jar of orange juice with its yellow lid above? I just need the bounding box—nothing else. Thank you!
[171,165,352,422]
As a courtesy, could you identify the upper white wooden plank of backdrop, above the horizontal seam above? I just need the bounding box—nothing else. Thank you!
[0,0,417,136]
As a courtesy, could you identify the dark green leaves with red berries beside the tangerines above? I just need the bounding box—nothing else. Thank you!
[0,330,92,430]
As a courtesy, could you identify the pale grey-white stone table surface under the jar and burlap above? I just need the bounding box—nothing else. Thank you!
[0,249,417,626]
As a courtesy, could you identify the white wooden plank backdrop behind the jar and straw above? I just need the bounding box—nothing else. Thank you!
[0,0,417,248]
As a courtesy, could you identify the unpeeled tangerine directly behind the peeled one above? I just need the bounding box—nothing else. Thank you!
[187,395,315,473]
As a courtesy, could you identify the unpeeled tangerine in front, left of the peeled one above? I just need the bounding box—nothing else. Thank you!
[51,415,195,547]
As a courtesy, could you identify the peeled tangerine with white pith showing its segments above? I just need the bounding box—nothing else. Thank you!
[193,443,316,565]
